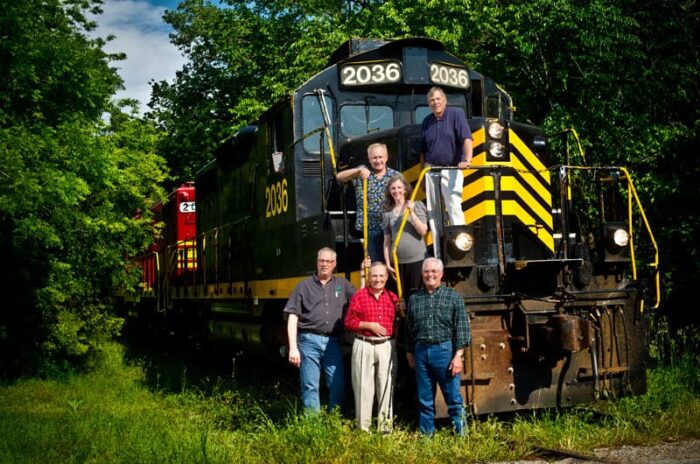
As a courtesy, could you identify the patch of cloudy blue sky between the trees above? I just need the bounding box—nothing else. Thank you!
[95,0,185,112]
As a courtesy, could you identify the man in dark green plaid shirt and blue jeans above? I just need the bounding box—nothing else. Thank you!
[406,258,471,435]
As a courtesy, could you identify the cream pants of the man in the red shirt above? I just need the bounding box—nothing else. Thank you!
[350,338,398,432]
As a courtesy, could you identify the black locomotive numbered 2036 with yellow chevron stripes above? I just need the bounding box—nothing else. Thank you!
[124,38,659,414]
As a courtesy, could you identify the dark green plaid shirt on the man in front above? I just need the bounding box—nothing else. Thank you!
[406,285,471,353]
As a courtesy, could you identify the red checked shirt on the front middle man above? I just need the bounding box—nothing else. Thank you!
[345,287,399,337]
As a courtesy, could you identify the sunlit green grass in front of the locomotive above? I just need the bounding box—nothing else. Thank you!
[0,336,700,464]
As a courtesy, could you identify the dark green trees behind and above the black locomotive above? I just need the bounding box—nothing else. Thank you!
[152,0,700,326]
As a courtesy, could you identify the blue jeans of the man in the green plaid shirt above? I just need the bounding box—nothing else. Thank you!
[413,341,464,435]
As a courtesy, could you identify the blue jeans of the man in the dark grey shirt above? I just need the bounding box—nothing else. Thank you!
[297,332,345,411]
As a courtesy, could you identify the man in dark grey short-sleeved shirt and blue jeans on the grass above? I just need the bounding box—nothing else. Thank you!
[284,247,355,412]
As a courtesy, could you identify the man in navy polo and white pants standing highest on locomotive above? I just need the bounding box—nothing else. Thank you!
[420,87,473,254]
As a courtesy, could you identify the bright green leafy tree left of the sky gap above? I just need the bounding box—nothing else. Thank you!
[0,0,165,375]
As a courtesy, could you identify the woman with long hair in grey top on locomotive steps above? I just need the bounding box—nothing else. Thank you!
[382,174,428,301]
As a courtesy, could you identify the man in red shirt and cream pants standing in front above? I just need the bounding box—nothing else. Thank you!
[345,262,399,433]
